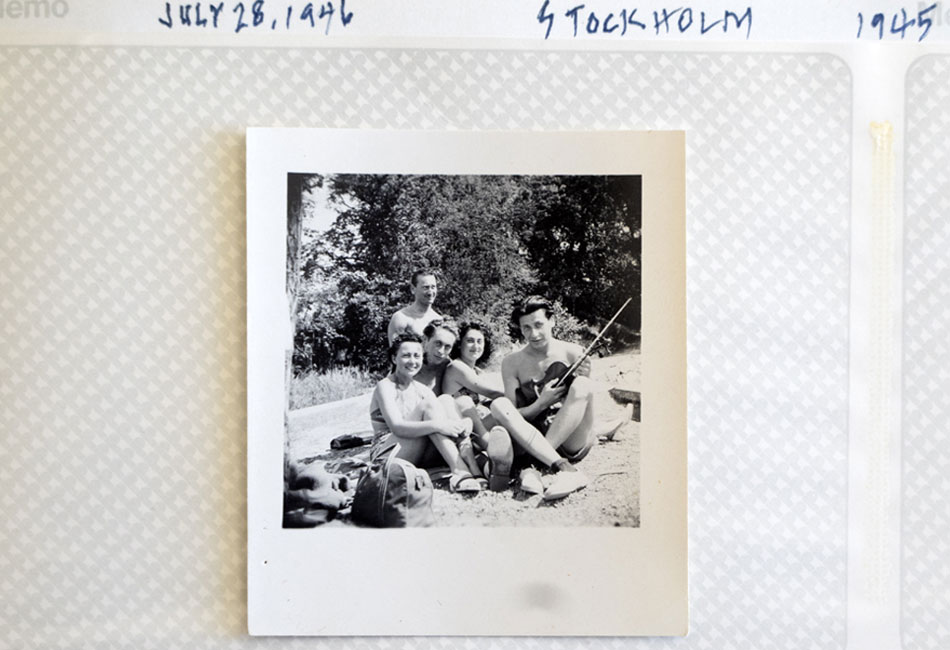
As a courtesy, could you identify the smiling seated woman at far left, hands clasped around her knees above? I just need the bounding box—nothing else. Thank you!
[369,334,482,492]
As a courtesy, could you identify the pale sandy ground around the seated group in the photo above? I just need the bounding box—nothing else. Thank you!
[288,351,640,526]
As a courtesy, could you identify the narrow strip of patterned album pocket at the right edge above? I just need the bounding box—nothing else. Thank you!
[901,56,950,650]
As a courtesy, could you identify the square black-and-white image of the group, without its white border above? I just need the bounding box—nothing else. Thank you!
[283,172,642,528]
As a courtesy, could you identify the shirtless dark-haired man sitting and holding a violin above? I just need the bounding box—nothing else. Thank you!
[491,296,594,500]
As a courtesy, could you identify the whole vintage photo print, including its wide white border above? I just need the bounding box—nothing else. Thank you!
[248,129,686,635]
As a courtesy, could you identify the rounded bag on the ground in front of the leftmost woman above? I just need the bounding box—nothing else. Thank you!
[350,449,435,528]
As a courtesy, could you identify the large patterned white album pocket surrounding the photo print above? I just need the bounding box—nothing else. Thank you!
[0,47,851,650]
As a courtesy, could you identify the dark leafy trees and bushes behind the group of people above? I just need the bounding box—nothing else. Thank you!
[288,174,640,373]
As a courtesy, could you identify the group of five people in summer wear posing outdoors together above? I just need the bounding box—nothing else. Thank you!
[370,271,620,500]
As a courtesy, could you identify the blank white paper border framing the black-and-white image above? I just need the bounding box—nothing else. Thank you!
[247,128,688,636]
